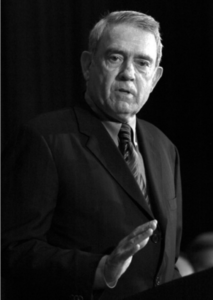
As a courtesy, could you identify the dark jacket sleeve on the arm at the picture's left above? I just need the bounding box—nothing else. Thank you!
[2,127,101,299]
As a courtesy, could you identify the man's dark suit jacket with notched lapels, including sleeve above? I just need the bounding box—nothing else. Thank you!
[2,103,181,299]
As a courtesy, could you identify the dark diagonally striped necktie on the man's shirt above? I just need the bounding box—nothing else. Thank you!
[118,124,150,206]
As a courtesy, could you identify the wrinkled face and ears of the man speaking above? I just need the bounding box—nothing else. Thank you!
[82,24,162,122]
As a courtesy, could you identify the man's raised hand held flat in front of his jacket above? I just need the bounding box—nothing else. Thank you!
[103,220,157,288]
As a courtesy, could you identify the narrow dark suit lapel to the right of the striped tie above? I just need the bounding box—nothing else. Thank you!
[137,121,167,232]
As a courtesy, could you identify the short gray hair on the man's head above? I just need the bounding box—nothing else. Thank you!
[89,11,163,66]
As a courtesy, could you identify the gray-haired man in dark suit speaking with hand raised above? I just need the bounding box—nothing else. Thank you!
[3,11,181,299]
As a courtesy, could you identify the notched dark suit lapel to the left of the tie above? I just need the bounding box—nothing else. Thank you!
[74,107,153,219]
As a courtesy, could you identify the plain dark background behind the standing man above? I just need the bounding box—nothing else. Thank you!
[2,0,213,250]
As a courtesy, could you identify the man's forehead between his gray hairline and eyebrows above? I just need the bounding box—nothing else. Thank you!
[97,24,157,61]
